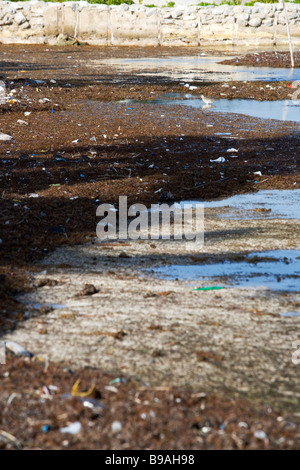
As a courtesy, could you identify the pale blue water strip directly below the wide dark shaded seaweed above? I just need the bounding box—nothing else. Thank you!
[180,189,300,219]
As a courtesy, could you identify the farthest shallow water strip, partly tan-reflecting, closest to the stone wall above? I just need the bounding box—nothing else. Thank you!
[93,54,300,82]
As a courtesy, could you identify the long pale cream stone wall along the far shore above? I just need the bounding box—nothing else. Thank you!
[0,0,300,46]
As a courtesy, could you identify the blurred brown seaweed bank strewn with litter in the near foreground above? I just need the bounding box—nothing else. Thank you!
[0,358,300,450]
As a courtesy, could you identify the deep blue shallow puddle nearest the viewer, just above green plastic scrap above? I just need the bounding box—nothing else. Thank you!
[151,250,300,292]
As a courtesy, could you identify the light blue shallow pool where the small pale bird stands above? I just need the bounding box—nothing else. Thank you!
[144,93,300,122]
